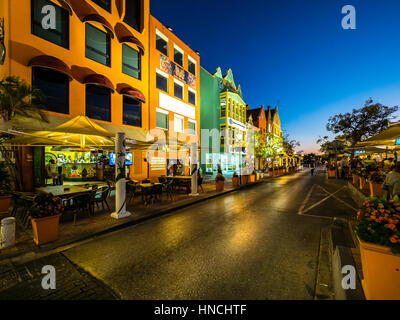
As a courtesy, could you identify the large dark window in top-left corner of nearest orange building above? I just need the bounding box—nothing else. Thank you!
[31,0,69,49]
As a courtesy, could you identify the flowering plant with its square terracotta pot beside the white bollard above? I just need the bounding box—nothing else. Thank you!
[29,193,64,246]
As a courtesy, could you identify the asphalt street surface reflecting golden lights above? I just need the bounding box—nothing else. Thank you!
[0,168,356,300]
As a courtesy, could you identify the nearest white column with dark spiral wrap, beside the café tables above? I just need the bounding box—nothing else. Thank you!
[111,132,131,219]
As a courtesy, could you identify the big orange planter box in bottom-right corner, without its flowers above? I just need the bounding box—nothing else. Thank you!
[358,239,400,300]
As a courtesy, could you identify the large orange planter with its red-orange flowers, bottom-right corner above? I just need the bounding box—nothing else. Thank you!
[355,193,400,300]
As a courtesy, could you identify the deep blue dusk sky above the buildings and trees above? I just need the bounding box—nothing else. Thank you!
[150,0,400,152]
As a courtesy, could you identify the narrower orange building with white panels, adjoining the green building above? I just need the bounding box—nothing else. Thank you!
[148,16,200,179]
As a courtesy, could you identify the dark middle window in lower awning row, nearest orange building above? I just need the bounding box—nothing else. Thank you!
[86,84,111,122]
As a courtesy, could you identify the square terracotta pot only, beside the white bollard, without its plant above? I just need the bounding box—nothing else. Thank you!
[31,214,60,246]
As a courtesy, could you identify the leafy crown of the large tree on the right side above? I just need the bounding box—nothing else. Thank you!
[326,98,398,157]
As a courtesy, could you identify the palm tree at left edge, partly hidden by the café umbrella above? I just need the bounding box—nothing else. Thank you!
[0,76,48,191]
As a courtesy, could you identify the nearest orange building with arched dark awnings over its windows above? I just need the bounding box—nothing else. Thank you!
[0,0,155,186]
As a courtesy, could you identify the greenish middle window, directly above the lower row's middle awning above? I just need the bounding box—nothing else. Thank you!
[86,23,111,67]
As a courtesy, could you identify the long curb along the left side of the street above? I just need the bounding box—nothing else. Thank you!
[0,170,300,265]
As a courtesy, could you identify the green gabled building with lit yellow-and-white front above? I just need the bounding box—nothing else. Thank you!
[200,67,247,174]
